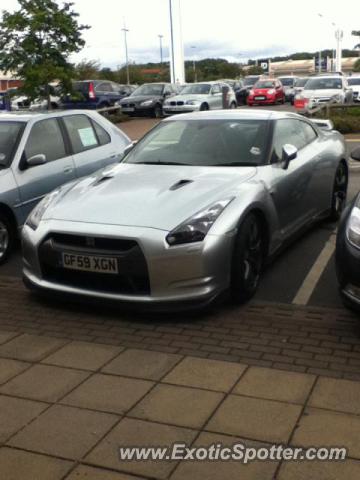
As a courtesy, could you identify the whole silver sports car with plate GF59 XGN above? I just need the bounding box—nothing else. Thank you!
[23,110,348,307]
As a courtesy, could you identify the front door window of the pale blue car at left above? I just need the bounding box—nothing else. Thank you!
[25,118,67,162]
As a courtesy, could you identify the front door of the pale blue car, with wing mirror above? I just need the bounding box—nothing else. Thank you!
[12,118,76,218]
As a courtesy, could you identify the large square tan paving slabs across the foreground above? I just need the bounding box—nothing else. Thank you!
[0,330,360,480]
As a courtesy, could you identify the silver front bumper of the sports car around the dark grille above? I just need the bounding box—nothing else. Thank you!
[22,221,234,306]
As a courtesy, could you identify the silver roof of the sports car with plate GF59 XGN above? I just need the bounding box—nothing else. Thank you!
[163,109,304,122]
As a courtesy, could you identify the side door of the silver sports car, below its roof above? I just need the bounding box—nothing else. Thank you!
[270,118,317,237]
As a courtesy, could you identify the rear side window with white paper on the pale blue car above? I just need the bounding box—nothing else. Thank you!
[63,115,99,153]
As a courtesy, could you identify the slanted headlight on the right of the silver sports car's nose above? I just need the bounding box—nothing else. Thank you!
[166,197,234,246]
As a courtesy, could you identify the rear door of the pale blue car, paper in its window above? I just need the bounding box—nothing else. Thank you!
[62,114,122,177]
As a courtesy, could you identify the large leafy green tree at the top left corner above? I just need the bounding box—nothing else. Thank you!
[0,0,89,107]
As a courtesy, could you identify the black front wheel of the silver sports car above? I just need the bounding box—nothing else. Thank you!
[230,213,265,304]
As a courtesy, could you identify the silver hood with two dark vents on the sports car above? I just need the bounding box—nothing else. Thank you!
[43,163,257,231]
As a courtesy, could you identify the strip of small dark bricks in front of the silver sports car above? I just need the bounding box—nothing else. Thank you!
[0,277,360,380]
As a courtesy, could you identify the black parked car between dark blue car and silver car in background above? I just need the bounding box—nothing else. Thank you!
[120,83,179,118]
